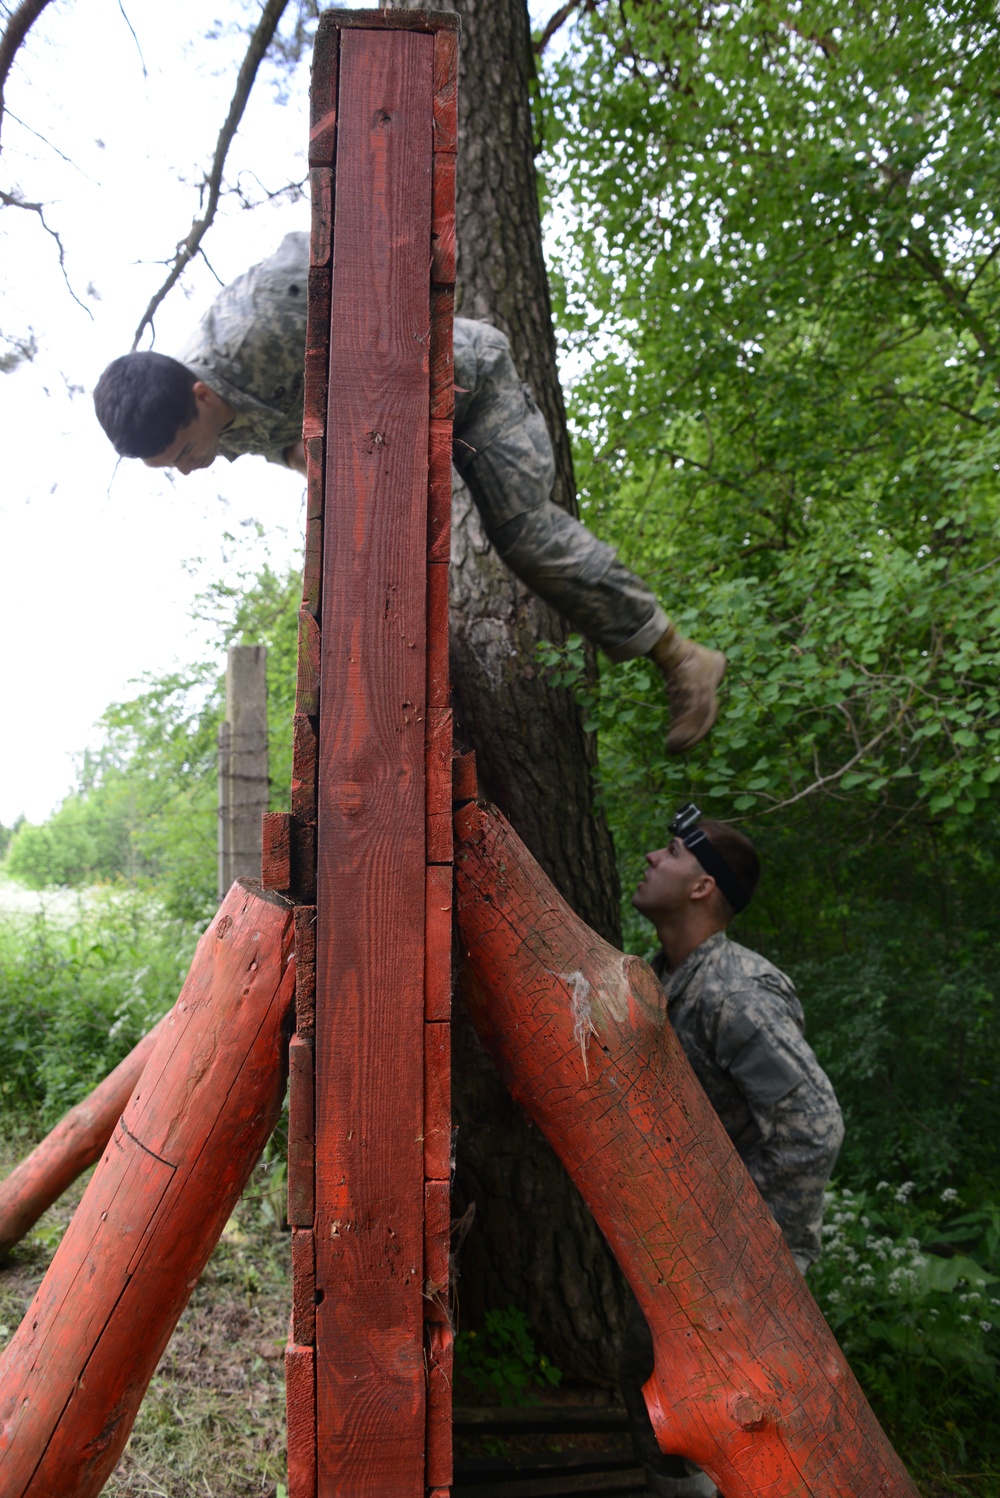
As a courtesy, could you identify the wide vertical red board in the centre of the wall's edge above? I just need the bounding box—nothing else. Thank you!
[316,30,434,1498]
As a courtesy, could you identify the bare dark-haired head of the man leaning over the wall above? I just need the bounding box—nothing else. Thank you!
[94,352,235,473]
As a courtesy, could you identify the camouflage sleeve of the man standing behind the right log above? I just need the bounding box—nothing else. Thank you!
[716,986,844,1269]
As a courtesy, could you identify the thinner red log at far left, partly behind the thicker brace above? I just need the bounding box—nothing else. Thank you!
[0,1012,166,1258]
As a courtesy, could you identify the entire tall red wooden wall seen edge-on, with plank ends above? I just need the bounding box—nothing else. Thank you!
[275,10,458,1498]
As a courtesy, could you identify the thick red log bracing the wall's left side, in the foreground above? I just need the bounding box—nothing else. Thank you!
[0,881,295,1498]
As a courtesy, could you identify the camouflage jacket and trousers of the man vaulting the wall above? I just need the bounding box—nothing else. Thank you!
[177,232,669,661]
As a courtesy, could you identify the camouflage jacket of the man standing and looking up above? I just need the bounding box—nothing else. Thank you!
[653,932,844,1269]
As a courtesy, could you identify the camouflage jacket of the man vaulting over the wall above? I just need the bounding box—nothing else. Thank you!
[177,231,482,464]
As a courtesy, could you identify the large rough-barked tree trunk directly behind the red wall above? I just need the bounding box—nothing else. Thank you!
[406,0,623,1384]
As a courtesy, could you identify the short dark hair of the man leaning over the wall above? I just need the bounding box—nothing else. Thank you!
[94,352,198,458]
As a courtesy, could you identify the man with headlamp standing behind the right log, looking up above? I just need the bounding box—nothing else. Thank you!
[620,806,844,1498]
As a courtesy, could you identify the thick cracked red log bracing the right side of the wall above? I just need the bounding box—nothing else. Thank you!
[455,804,916,1498]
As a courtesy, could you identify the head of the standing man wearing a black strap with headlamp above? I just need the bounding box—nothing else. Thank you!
[632,807,760,930]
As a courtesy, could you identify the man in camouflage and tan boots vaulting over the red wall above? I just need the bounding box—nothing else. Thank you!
[94,232,726,753]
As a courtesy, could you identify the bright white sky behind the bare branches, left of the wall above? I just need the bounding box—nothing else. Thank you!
[0,0,551,827]
